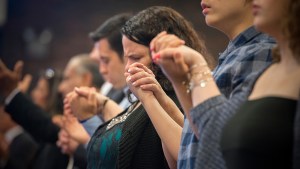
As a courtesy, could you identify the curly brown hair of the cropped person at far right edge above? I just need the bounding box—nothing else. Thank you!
[273,0,300,63]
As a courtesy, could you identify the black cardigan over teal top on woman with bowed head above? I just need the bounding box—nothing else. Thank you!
[87,92,179,169]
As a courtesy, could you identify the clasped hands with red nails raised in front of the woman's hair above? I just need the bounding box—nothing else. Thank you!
[150,32,206,83]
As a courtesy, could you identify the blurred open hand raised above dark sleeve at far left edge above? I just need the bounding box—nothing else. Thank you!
[0,59,23,98]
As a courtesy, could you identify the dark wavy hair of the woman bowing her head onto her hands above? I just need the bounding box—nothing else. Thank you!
[121,6,214,91]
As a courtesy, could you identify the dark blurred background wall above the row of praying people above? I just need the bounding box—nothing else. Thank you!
[0,0,228,74]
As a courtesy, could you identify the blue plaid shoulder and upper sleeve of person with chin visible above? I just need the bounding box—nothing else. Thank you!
[214,43,274,98]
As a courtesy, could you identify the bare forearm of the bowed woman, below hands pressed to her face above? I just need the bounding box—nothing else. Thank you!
[141,96,182,160]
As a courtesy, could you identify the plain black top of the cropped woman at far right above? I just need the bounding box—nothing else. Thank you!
[221,97,297,169]
